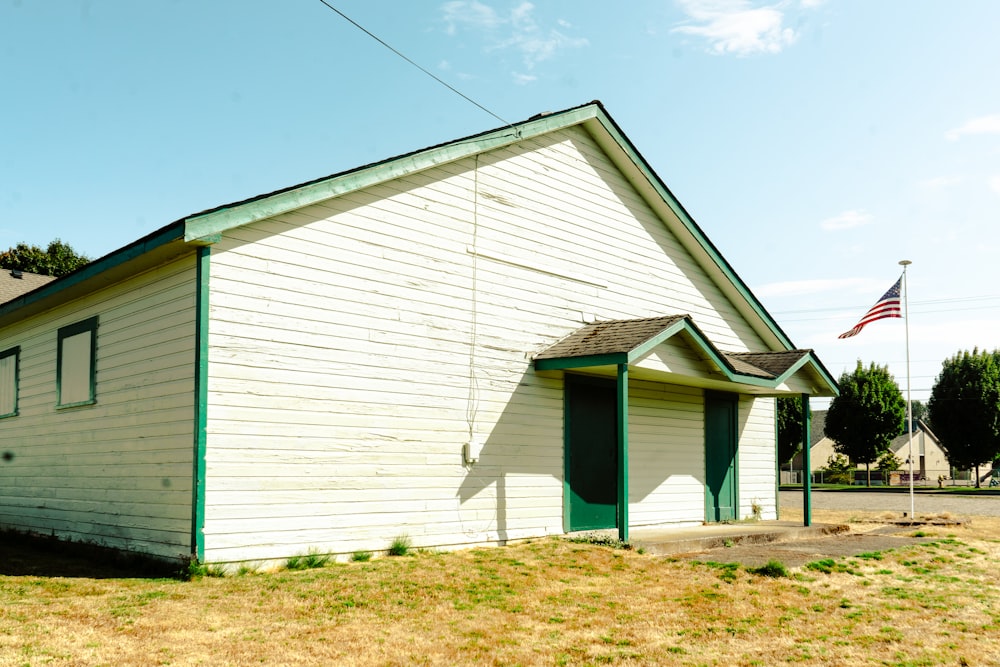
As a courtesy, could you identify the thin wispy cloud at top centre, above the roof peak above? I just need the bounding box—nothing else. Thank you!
[441,0,590,79]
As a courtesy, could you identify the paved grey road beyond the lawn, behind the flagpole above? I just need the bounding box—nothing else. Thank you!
[780,490,1000,517]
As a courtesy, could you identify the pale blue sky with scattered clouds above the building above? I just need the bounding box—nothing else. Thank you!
[0,0,1000,408]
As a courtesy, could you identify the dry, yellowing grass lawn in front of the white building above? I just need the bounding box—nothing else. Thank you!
[0,512,1000,666]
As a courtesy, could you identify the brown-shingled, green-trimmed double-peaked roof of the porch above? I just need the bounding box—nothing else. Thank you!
[534,315,837,395]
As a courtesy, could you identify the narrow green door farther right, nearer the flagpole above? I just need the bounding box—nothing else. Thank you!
[705,395,737,521]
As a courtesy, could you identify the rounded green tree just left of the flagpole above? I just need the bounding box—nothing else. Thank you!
[826,359,906,486]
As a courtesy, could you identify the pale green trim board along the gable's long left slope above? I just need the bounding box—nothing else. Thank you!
[184,105,599,242]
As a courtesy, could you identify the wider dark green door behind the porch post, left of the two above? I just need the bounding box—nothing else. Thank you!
[566,376,618,530]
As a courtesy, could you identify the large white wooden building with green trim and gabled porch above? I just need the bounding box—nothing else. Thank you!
[0,103,837,562]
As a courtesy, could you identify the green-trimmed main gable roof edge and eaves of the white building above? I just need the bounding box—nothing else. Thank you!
[0,101,836,380]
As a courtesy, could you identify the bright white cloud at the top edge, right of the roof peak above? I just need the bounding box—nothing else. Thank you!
[671,0,808,56]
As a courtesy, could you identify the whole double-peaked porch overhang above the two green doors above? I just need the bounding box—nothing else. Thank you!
[534,315,839,397]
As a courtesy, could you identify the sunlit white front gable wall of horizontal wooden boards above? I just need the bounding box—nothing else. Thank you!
[205,129,773,561]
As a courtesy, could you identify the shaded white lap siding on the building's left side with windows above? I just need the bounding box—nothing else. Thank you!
[0,257,195,558]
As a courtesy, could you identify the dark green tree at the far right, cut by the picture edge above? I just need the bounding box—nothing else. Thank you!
[928,348,1000,487]
